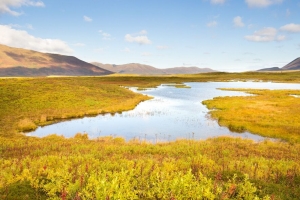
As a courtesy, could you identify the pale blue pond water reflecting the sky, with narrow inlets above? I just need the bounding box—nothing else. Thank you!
[28,82,300,141]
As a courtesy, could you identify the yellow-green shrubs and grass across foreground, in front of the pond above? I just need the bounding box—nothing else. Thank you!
[0,134,300,200]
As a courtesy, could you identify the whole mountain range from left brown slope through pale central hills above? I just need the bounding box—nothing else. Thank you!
[0,44,214,77]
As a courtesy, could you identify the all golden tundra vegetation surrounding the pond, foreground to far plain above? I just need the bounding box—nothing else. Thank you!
[0,72,300,199]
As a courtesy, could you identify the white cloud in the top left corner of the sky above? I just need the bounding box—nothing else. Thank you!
[0,0,45,16]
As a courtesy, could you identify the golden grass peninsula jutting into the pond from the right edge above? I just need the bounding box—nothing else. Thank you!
[203,89,300,143]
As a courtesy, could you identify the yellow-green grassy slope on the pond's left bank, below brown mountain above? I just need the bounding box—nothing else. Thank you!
[0,78,150,136]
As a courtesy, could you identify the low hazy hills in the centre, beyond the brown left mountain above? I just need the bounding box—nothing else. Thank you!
[91,62,216,74]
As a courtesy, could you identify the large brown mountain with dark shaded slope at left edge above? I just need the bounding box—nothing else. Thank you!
[0,44,113,76]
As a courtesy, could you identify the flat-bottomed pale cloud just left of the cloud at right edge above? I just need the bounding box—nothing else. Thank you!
[245,27,286,42]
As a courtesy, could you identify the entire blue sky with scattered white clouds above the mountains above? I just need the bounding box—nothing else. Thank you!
[0,0,300,72]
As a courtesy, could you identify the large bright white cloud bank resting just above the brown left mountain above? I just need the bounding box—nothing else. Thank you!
[0,25,73,54]
